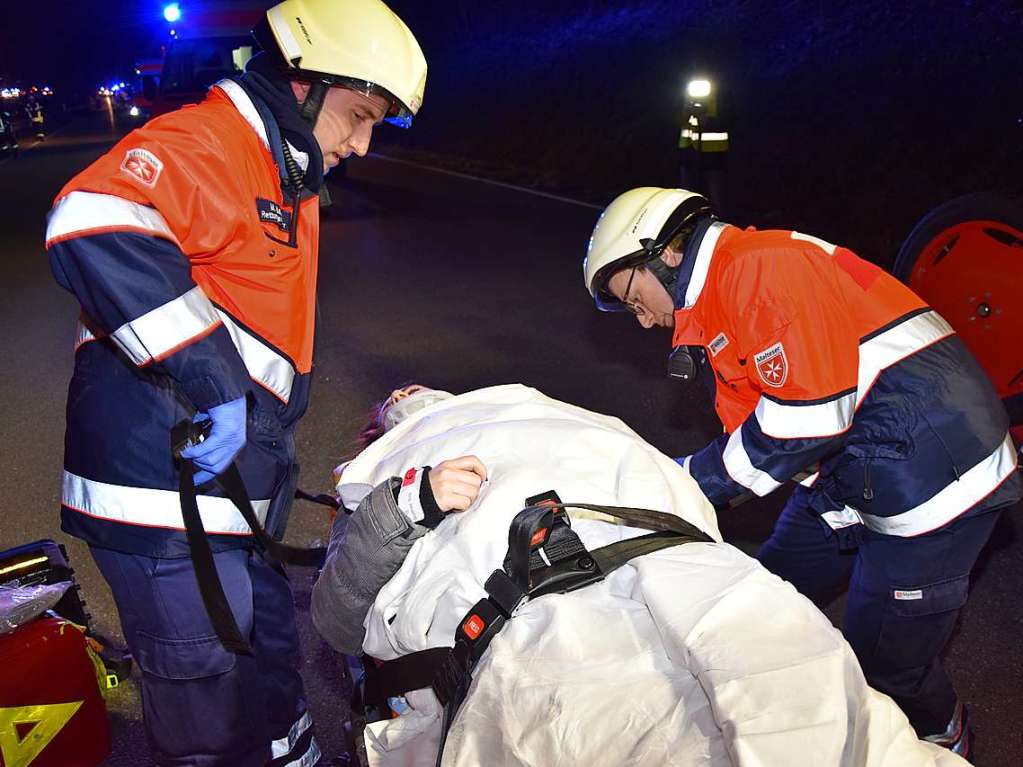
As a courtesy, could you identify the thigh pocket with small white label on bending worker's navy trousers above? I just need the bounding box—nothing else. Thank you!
[876,575,970,668]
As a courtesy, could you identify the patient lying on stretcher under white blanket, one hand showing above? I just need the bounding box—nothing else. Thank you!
[312,385,967,767]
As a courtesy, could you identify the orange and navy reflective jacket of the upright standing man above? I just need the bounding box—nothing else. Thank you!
[46,81,319,556]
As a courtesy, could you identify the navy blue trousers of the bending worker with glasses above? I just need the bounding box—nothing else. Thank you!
[757,488,1000,737]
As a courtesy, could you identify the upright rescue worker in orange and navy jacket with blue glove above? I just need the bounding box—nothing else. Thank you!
[46,0,427,767]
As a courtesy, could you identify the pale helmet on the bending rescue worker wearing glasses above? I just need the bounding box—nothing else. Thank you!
[582,186,711,312]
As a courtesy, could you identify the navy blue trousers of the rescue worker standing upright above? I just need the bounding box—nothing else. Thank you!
[92,547,319,767]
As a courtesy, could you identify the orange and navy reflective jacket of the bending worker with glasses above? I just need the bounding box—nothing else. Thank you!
[674,223,1021,536]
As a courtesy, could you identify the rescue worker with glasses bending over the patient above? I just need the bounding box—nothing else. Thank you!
[583,187,1021,755]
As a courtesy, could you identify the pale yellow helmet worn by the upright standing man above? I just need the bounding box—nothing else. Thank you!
[254,0,427,128]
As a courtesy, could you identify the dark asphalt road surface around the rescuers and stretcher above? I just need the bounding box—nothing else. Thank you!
[0,112,1023,767]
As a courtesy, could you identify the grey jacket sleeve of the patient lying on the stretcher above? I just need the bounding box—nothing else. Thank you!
[311,479,428,656]
